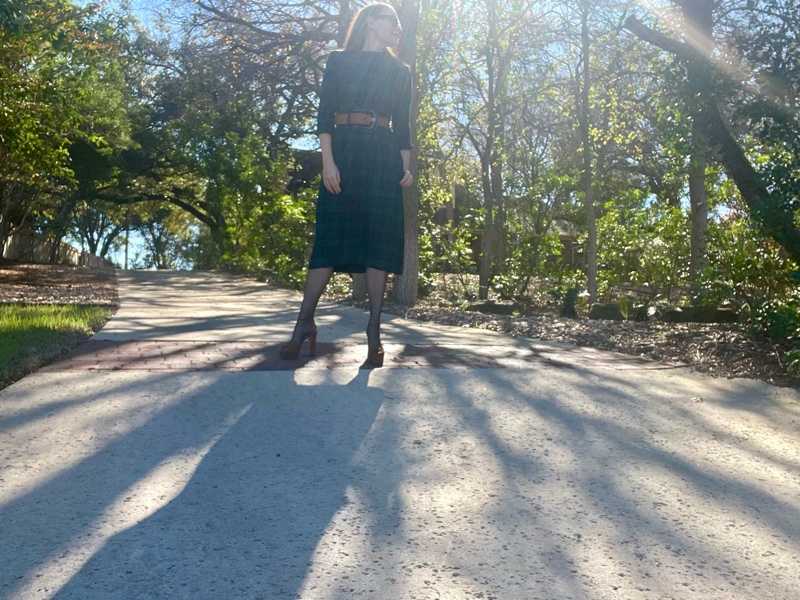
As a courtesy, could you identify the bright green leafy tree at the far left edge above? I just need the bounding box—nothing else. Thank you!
[0,0,139,260]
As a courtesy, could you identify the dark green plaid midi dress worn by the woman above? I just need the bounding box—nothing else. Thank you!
[308,51,411,273]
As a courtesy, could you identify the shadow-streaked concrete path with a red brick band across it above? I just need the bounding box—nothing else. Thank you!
[0,273,800,600]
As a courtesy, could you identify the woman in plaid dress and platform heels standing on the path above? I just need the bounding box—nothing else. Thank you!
[281,3,414,367]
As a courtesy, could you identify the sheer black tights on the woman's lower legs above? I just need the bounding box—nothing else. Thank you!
[292,267,389,348]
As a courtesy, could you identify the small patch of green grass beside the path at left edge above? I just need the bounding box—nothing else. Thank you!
[0,304,114,389]
